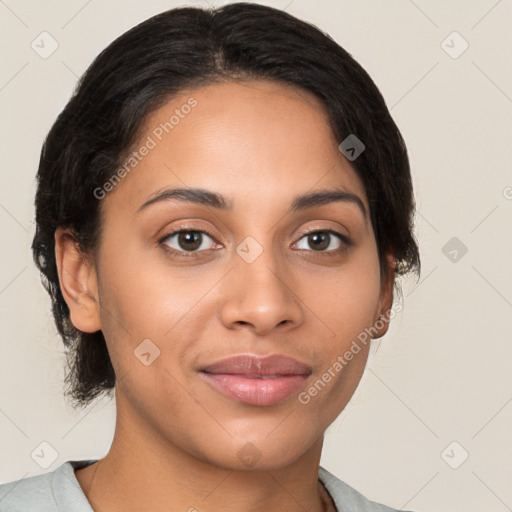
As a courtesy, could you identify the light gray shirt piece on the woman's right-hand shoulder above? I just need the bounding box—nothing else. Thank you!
[318,466,414,512]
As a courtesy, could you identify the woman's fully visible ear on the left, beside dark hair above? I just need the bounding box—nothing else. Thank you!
[55,227,101,332]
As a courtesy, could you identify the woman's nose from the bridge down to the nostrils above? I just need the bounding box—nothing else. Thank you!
[218,237,302,333]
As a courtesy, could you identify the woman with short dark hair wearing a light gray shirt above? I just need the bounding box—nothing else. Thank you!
[0,3,420,512]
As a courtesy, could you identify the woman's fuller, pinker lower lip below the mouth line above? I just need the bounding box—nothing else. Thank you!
[201,372,308,405]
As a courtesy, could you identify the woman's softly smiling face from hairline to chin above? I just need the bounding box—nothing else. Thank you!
[62,81,392,468]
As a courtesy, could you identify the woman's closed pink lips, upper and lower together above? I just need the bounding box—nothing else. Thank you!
[200,354,312,406]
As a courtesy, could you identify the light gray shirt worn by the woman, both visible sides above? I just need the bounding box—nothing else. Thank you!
[0,460,410,512]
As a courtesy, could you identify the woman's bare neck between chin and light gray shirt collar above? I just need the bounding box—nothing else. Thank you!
[75,386,326,512]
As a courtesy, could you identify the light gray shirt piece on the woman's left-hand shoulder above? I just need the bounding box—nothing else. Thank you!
[0,461,94,512]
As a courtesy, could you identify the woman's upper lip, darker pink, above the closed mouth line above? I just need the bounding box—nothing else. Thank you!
[201,354,312,376]
